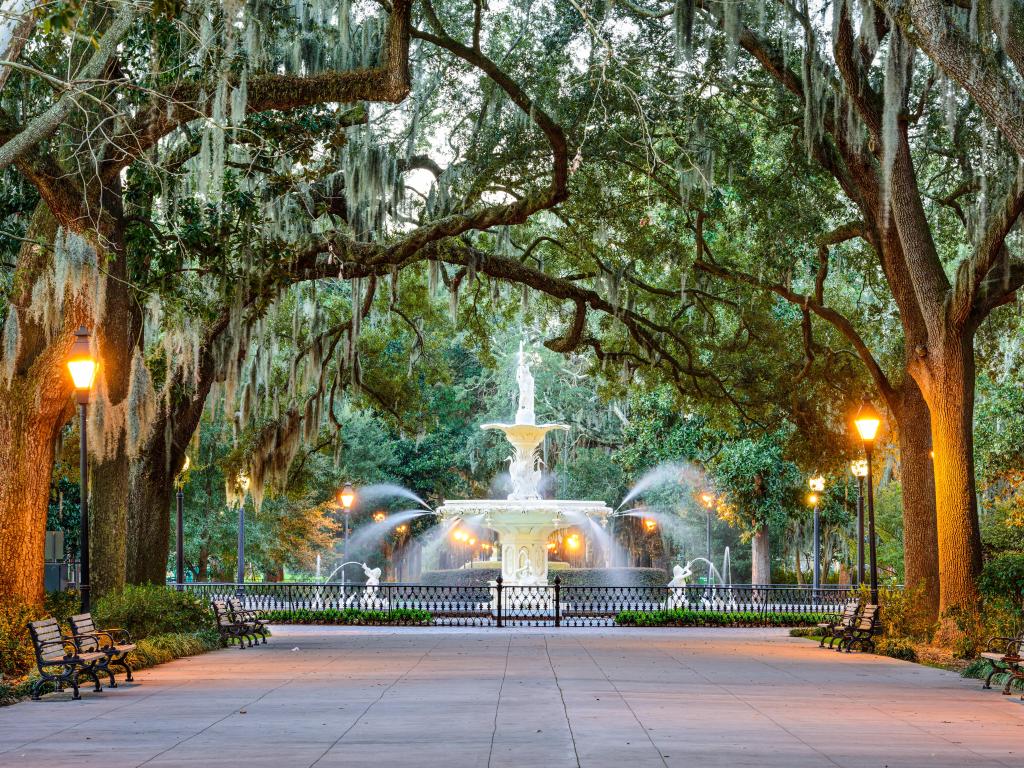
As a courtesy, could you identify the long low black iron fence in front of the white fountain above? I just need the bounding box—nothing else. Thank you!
[181,579,856,627]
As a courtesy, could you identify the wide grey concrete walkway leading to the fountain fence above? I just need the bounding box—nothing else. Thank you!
[0,627,1024,768]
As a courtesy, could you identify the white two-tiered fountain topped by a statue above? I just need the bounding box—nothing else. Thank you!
[437,342,611,587]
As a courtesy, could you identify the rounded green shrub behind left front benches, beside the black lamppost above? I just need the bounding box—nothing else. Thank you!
[93,585,214,640]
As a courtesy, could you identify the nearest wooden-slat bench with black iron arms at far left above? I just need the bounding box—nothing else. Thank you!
[29,618,111,701]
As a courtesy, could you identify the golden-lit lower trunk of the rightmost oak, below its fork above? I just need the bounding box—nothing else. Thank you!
[923,331,981,614]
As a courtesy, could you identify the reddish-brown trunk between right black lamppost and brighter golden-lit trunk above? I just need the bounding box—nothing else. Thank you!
[893,376,939,621]
